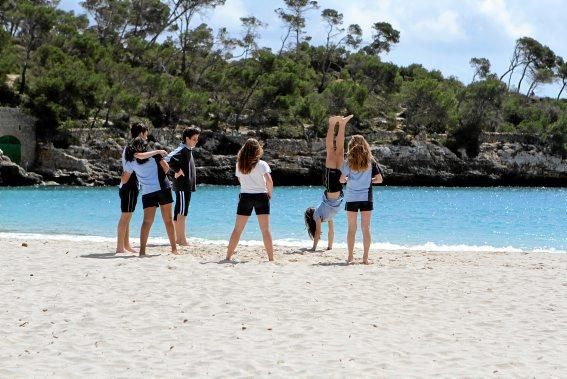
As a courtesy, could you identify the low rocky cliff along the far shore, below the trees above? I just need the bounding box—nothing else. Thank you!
[0,129,567,187]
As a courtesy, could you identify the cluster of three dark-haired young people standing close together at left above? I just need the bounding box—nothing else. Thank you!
[116,123,201,256]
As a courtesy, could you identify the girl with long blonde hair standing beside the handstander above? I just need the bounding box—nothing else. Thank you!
[340,135,383,264]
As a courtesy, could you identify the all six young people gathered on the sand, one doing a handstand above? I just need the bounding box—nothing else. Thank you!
[116,115,383,264]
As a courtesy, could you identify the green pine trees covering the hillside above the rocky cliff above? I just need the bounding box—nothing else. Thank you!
[0,0,567,156]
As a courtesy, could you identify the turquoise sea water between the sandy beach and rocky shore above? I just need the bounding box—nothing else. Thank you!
[0,186,567,252]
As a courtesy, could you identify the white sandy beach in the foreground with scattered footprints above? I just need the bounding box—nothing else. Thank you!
[0,238,567,378]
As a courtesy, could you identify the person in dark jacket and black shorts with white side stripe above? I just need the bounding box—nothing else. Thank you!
[165,126,201,246]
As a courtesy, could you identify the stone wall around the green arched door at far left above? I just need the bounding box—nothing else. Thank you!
[0,107,36,170]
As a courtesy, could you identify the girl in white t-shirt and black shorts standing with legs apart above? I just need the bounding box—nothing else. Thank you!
[226,138,274,262]
